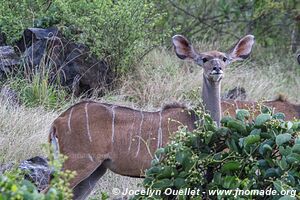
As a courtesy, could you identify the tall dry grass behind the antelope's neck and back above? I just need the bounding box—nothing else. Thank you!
[103,44,300,109]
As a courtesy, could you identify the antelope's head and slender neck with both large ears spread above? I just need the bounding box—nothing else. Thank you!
[172,35,254,126]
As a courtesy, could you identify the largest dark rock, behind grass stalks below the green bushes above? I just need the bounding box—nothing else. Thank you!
[18,28,114,96]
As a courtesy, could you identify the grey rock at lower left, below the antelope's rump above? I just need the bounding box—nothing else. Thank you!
[19,156,51,191]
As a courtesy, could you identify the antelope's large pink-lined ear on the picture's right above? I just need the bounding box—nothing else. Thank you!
[228,35,255,61]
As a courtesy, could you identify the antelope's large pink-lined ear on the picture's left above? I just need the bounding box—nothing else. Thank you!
[172,35,199,61]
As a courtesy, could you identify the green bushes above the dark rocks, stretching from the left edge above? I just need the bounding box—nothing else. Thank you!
[0,0,168,75]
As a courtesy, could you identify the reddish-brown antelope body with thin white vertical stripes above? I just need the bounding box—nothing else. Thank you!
[49,101,196,198]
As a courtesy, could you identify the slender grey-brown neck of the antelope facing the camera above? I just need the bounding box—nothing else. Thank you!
[202,75,221,126]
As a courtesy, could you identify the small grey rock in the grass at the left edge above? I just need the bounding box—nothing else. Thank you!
[0,86,20,107]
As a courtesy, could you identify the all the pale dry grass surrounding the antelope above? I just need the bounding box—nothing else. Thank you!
[0,43,300,198]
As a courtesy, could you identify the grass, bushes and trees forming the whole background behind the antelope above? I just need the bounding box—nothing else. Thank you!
[0,0,300,198]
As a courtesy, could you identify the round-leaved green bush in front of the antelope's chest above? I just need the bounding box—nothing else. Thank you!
[135,107,300,199]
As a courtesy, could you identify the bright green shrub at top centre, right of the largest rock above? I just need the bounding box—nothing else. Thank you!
[53,0,168,74]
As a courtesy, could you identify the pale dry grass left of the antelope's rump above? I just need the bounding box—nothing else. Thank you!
[0,102,57,163]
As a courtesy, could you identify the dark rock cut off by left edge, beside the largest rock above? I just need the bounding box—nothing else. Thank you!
[0,46,20,81]
